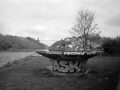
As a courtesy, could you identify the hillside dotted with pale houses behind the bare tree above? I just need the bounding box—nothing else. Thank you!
[49,37,102,51]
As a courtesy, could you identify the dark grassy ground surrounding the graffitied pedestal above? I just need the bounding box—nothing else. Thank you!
[0,56,120,90]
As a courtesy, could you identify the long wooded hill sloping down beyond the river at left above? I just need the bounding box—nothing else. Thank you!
[0,34,46,51]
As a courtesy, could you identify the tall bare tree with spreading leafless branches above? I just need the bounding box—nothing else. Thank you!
[70,9,100,52]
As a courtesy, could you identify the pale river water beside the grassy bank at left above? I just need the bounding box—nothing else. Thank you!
[0,51,38,67]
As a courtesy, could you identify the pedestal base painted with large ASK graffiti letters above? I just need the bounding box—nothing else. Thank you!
[52,60,86,73]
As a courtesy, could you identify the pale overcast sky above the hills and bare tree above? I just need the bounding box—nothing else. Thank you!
[0,0,120,45]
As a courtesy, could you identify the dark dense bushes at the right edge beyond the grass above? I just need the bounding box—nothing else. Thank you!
[102,37,120,55]
